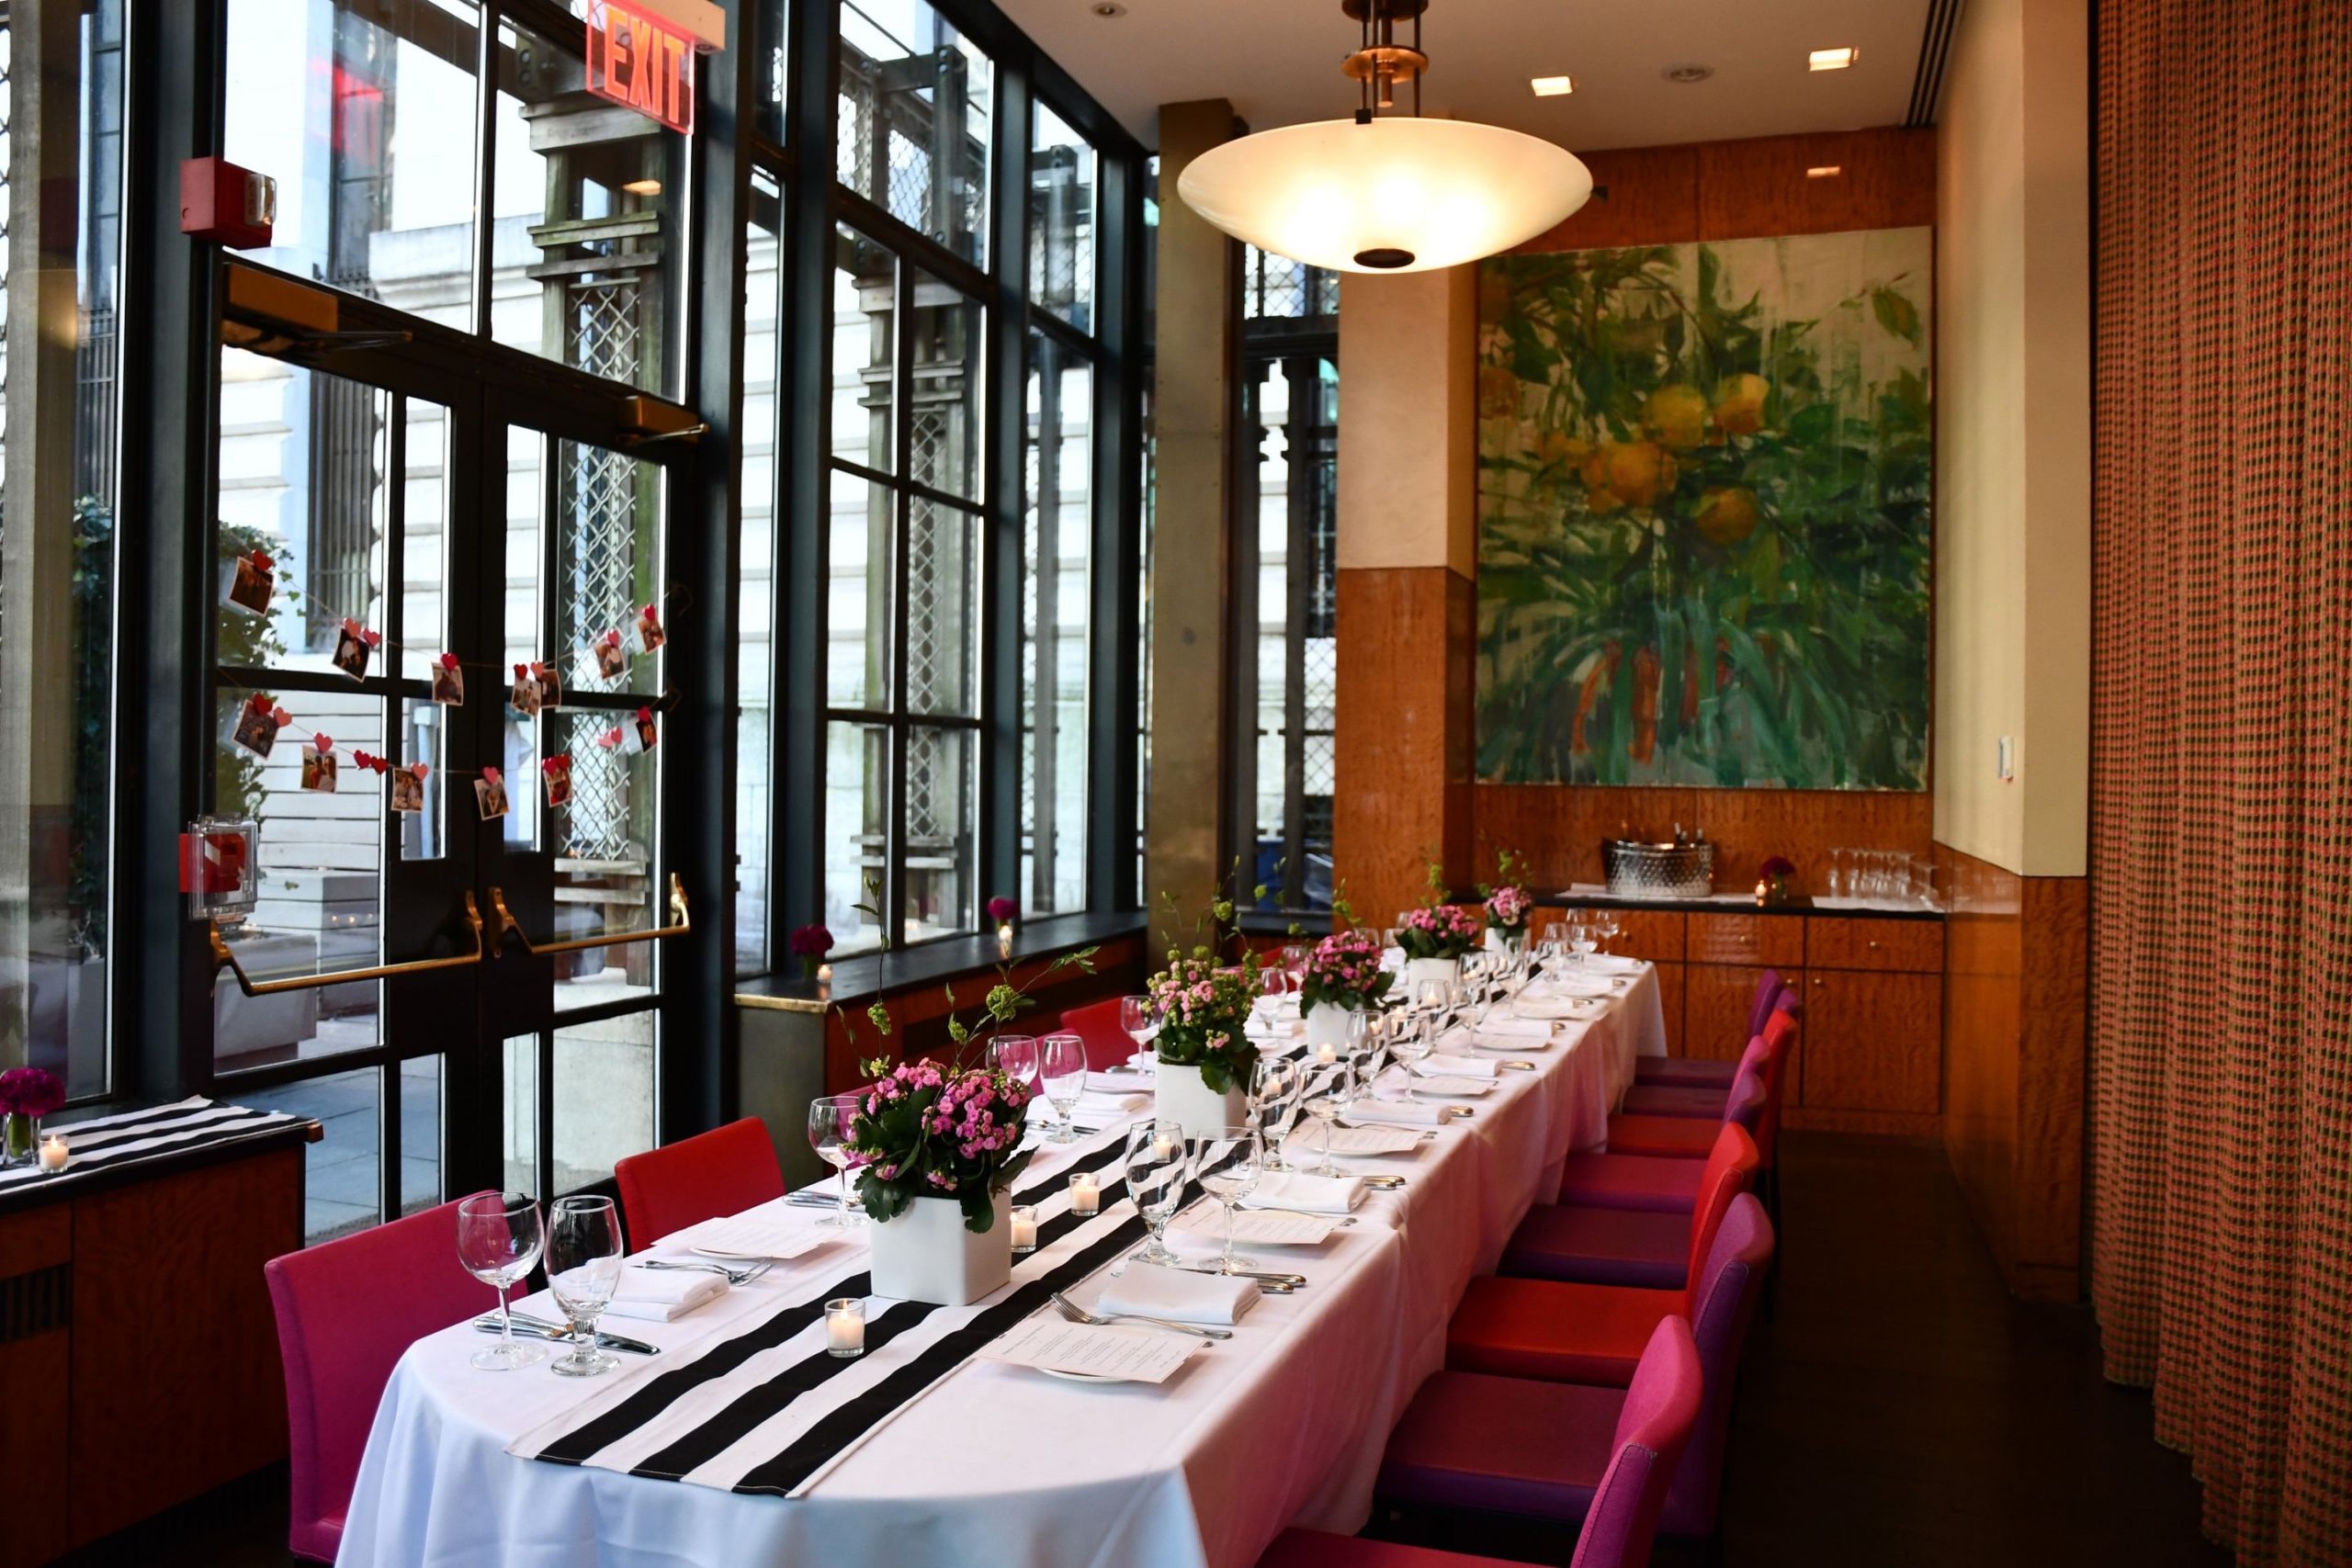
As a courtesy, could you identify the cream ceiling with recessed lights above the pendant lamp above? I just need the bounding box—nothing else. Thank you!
[997,0,1931,151]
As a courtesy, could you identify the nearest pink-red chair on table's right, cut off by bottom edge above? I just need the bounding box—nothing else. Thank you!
[1259,1316,1705,1568]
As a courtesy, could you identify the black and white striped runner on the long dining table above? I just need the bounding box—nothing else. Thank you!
[505,1123,1250,1497]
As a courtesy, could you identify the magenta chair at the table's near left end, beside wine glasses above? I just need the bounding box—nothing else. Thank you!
[261,1199,501,1563]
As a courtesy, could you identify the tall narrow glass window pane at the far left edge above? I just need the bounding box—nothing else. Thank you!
[0,0,136,1098]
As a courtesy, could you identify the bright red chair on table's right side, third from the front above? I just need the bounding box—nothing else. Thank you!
[1446,1152,1738,1389]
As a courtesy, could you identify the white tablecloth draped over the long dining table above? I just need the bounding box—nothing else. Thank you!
[336,962,1665,1568]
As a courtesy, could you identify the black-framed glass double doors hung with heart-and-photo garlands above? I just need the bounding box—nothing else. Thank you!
[209,344,689,1241]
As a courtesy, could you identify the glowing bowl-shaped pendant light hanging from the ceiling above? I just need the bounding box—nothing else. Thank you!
[1176,0,1592,273]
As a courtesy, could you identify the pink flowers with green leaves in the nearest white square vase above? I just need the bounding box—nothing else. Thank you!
[844,1058,1030,1232]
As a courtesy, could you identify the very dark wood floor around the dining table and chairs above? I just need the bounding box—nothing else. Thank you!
[55,1134,2230,1568]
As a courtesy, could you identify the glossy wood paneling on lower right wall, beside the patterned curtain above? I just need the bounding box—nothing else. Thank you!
[1936,844,2088,1300]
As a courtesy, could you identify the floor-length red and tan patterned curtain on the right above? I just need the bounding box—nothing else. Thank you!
[2091,0,2352,1563]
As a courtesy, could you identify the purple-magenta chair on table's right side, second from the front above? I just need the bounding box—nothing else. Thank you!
[1378,1194,1773,1535]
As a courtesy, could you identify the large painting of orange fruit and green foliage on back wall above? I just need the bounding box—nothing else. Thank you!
[1477,228,1933,790]
